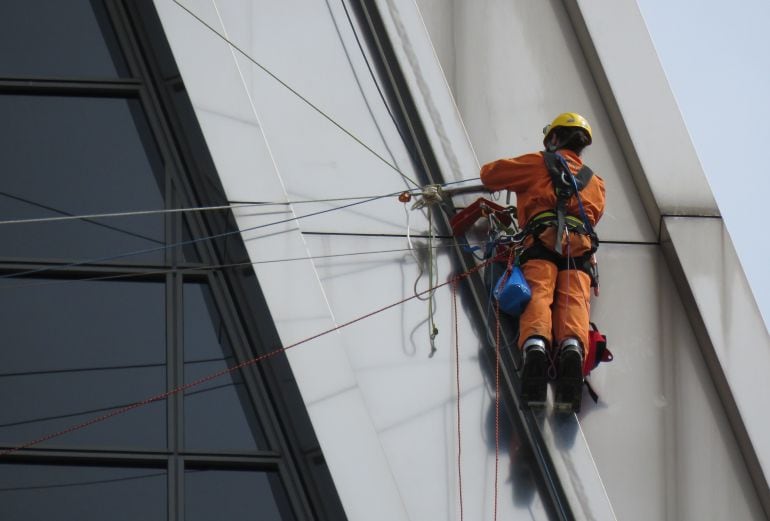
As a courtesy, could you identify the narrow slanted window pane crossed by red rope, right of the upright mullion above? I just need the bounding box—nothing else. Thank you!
[184,283,268,450]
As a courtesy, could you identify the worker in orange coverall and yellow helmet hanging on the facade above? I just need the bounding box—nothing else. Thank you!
[481,112,605,412]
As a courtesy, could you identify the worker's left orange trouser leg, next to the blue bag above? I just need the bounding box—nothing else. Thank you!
[519,259,558,347]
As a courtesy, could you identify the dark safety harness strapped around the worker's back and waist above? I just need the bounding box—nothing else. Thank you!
[519,152,599,288]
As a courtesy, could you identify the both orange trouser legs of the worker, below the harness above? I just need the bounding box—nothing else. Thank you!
[519,259,591,360]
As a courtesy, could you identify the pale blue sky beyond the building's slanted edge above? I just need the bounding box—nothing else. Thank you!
[637,0,770,329]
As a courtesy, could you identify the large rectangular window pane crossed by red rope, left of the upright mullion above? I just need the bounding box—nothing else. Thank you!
[0,279,166,448]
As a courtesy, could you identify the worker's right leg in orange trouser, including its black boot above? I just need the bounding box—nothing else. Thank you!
[553,270,591,412]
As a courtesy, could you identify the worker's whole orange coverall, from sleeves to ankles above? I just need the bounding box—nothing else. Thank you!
[481,149,604,360]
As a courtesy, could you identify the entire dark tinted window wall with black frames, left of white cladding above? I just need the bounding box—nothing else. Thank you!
[0,0,343,521]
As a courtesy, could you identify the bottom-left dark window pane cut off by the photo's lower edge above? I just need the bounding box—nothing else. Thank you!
[0,464,166,521]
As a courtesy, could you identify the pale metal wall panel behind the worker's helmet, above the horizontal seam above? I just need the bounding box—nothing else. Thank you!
[418,0,657,241]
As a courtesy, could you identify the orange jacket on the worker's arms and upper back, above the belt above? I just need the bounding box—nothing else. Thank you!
[481,149,604,226]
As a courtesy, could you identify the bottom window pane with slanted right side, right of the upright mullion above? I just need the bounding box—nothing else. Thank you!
[185,469,296,521]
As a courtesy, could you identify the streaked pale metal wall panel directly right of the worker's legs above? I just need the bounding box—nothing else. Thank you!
[580,245,763,520]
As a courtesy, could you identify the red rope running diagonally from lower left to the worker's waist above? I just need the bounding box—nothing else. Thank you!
[0,257,497,458]
